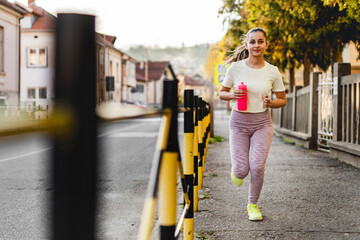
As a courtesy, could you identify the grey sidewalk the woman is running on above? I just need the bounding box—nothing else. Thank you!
[194,110,360,240]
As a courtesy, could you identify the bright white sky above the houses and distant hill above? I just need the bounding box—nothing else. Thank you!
[14,0,226,48]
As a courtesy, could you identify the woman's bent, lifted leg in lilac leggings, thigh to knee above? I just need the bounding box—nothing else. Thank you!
[229,112,250,179]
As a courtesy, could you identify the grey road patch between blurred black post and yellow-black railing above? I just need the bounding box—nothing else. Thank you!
[98,118,160,239]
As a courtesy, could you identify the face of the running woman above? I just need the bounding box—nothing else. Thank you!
[245,31,268,57]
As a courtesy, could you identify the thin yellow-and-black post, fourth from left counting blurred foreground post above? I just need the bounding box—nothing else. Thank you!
[194,96,199,212]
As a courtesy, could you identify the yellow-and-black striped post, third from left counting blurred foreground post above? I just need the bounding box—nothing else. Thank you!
[184,90,194,240]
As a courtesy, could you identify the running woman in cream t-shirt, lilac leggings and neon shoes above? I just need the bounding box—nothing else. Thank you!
[219,28,286,221]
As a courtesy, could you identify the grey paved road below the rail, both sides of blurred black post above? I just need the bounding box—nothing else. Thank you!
[0,117,181,240]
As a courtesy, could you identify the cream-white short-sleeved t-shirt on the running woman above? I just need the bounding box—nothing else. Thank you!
[222,59,285,113]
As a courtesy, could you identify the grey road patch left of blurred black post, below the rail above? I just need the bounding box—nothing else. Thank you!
[0,134,51,239]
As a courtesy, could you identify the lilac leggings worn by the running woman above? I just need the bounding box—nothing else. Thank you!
[229,111,273,204]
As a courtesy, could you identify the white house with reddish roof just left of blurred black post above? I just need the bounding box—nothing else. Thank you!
[16,0,56,108]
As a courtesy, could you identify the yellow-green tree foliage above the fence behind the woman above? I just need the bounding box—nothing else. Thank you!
[214,0,360,85]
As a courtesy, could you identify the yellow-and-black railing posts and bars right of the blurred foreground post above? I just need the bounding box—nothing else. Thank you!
[138,86,210,240]
